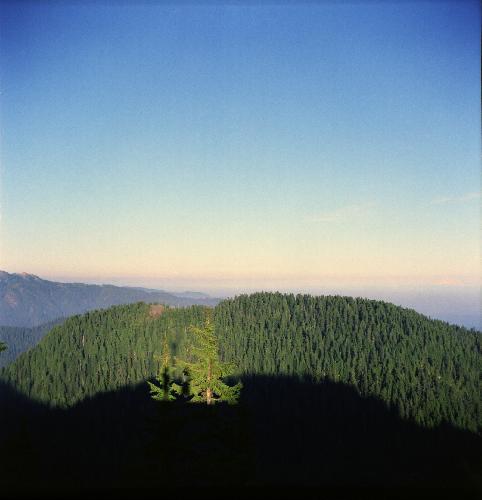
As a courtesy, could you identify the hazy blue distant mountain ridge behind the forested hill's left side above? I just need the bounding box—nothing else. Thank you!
[0,271,220,327]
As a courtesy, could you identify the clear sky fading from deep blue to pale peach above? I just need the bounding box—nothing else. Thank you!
[0,0,481,328]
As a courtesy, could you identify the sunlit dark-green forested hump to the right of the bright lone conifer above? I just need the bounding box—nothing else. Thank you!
[215,293,482,431]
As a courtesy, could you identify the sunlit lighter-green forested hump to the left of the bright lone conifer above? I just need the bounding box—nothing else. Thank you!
[0,303,205,407]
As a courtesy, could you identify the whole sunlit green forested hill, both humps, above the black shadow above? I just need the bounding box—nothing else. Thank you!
[1,293,481,431]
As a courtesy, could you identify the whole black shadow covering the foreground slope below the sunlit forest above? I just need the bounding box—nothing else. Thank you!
[0,376,482,492]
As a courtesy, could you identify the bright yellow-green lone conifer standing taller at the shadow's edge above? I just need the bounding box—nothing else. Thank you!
[175,310,242,405]
